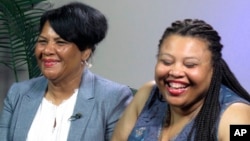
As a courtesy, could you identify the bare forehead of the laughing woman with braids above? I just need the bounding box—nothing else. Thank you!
[159,35,211,57]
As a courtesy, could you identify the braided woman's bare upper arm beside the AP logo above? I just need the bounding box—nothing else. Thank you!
[218,103,250,141]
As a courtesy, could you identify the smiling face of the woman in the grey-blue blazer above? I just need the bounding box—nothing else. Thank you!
[35,22,87,83]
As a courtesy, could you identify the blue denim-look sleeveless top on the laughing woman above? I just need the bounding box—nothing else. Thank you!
[128,85,250,141]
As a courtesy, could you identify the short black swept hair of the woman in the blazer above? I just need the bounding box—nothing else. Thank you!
[39,2,108,52]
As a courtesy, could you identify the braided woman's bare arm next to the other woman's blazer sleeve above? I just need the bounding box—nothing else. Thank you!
[112,81,154,141]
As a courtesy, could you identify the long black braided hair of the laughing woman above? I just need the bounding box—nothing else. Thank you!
[158,19,250,141]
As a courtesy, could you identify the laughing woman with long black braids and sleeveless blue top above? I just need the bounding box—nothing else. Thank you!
[112,19,250,141]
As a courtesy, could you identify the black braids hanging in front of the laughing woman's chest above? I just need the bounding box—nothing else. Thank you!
[188,64,221,141]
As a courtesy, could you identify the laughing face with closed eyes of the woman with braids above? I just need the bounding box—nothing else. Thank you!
[155,35,213,108]
